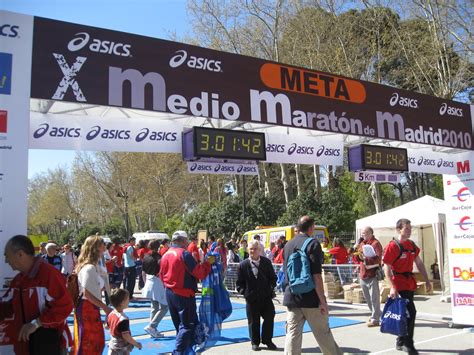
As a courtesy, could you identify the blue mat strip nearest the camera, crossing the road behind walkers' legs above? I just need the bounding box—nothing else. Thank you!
[103,317,363,355]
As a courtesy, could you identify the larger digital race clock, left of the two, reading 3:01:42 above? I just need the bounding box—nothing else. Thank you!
[183,127,267,160]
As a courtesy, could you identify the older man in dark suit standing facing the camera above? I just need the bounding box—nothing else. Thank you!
[237,240,277,351]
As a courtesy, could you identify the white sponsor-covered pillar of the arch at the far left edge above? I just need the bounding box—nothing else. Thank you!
[0,11,33,354]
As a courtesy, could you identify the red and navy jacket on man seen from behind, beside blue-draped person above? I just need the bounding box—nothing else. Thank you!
[160,247,211,297]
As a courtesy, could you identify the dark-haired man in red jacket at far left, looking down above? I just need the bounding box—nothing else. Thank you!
[0,235,73,355]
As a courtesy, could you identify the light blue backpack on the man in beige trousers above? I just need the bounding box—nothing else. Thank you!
[286,238,314,295]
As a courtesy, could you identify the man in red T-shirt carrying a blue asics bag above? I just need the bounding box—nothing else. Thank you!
[383,218,431,355]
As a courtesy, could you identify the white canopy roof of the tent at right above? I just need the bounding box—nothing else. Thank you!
[356,195,446,230]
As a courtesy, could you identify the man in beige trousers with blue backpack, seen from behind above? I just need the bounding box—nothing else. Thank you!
[283,216,342,355]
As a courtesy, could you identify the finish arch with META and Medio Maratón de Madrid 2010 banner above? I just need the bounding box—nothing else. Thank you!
[0,11,474,338]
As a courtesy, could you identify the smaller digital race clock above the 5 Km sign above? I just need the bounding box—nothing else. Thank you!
[349,144,408,172]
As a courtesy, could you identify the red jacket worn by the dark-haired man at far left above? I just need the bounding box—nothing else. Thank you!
[0,257,73,355]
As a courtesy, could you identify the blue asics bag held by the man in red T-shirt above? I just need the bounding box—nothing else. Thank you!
[380,297,408,336]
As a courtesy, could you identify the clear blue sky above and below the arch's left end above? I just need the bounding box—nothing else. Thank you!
[0,0,191,179]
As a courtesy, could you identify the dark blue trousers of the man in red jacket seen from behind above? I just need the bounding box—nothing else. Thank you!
[166,288,198,355]
